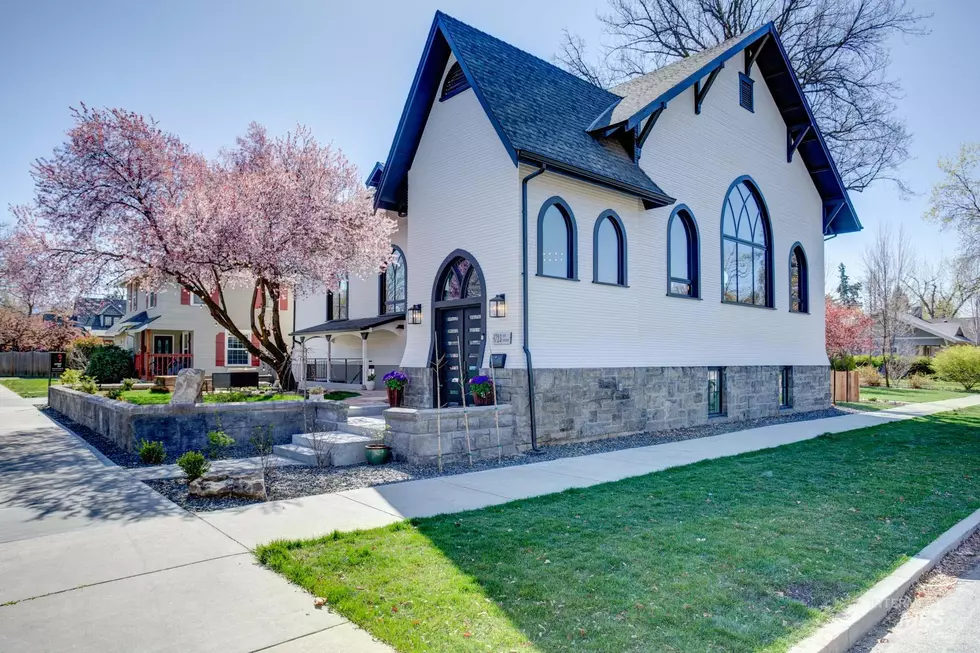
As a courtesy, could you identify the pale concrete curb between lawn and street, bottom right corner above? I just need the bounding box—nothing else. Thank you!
[790,510,980,653]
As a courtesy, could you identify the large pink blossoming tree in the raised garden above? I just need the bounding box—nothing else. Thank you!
[16,105,395,387]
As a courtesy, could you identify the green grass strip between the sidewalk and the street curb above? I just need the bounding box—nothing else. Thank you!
[256,409,980,653]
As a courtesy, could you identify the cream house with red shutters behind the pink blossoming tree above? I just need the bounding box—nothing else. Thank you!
[106,283,293,379]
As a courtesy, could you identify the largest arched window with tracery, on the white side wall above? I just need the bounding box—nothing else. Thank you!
[721,177,773,308]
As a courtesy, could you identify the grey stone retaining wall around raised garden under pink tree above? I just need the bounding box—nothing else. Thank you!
[48,386,348,452]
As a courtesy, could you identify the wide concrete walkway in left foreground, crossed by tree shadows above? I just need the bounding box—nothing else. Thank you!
[0,386,390,653]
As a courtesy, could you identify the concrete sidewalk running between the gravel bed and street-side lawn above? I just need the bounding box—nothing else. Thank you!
[200,395,980,548]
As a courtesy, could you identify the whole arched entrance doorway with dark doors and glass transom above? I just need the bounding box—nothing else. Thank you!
[432,250,486,406]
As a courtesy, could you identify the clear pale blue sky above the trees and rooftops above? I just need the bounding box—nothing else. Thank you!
[0,0,968,287]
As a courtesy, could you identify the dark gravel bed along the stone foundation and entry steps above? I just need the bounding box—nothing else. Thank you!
[144,408,849,512]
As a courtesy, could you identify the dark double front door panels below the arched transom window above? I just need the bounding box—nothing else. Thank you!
[436,304,483,406]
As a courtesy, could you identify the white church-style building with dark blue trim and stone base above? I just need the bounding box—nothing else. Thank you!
[296,13,861,443]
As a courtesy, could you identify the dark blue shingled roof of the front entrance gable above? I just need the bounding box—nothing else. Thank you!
[375,12,674,210]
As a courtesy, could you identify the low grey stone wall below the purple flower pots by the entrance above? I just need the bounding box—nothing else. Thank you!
[384,405,519,466]
